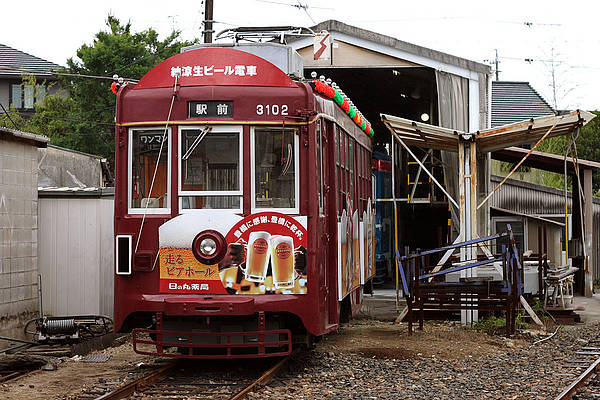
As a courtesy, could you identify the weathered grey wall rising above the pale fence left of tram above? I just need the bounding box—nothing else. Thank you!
[38,146,102,187]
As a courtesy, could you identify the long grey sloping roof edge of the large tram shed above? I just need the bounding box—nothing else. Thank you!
[288,20,491,74]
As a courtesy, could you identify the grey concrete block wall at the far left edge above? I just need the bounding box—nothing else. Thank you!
[0,138,38,320]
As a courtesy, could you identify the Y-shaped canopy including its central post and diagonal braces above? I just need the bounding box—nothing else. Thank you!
[381,110,595,323]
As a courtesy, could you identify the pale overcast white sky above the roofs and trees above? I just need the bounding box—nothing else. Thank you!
[0,0,600,110]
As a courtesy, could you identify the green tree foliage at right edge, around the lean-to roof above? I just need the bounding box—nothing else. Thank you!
[539,111,600,193]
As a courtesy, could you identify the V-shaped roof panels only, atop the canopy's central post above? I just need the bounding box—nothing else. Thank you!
[381,110,595,153]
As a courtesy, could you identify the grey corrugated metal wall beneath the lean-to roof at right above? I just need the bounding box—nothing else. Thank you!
[490,175,600,277]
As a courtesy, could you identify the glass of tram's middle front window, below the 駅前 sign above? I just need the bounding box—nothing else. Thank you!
[179,127,242,210]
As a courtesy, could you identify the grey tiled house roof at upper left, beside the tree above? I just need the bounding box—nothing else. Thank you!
[0,43,60,77]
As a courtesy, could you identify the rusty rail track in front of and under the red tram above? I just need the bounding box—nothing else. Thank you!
[84,356,290,400]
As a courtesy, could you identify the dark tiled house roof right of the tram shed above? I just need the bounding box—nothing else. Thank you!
[492,81,556,128]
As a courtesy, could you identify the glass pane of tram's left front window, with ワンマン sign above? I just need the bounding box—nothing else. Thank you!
[130,129,169,209]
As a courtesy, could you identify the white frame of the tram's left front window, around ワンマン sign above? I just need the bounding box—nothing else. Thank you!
[127,127,173,215]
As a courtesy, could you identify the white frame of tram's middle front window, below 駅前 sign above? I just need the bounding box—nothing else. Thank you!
[177,125,244,214]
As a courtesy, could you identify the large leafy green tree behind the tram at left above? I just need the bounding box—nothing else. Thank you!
[26,15,197,161]
